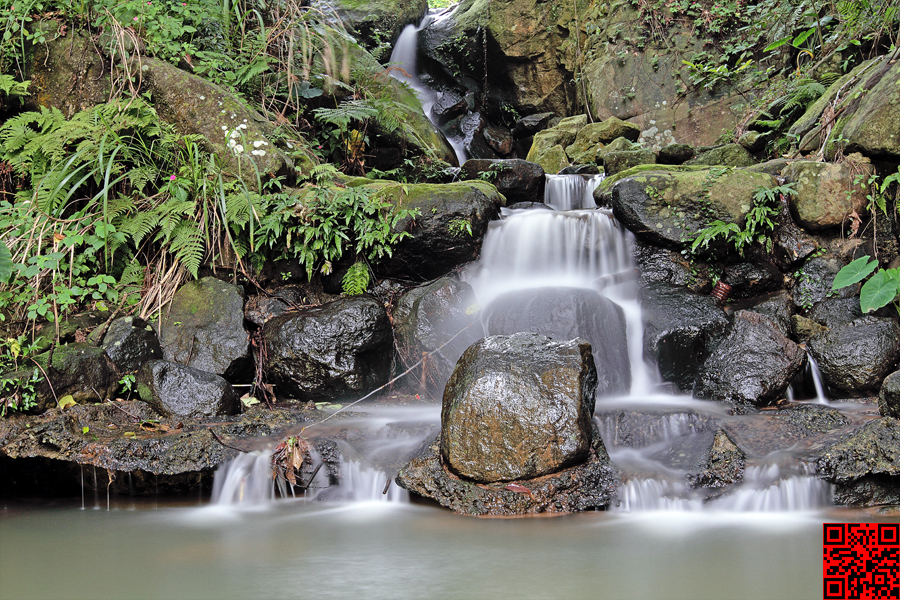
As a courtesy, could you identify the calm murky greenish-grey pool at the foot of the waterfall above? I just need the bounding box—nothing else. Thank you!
[0,498,884,600]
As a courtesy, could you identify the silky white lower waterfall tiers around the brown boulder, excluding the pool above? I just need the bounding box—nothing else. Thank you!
[214,168,830,511]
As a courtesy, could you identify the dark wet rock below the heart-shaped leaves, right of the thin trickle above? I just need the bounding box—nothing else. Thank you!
[809,317,900,394]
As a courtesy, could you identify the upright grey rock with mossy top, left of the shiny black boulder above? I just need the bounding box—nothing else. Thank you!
[159,277,253,383]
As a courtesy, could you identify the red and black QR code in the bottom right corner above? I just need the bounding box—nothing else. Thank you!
[822,523,900,600]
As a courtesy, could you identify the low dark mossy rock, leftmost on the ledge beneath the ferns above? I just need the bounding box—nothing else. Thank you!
[29,343,120,412]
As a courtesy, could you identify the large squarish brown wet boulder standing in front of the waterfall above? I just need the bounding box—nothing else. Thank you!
[441,333,597,483]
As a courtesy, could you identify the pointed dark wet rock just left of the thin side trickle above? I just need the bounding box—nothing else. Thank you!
[694,311,806,406]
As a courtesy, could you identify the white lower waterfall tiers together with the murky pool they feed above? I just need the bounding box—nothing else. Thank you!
[0,171,879,600]
